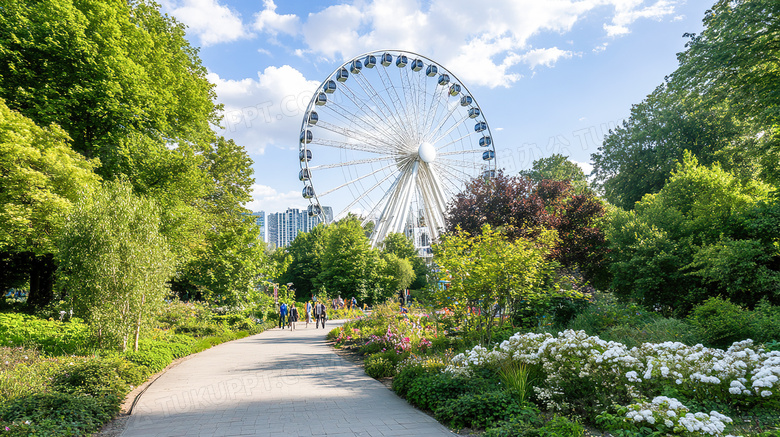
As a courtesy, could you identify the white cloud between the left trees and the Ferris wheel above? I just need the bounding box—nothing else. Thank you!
[208,65,319,154]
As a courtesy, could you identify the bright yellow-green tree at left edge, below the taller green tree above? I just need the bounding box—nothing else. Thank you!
[0,99,100,307]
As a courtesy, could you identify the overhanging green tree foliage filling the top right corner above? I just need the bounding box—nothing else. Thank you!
[670,0,780,186]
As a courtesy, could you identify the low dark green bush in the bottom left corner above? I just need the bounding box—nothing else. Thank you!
[0,393,121,437]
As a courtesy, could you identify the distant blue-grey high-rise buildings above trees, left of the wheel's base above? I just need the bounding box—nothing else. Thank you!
[252,206,333,247]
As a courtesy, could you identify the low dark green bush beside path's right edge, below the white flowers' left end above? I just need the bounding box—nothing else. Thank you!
[435,391,523,428]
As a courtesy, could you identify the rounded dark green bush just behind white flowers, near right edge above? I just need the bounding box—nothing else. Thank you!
[689,297,753,349]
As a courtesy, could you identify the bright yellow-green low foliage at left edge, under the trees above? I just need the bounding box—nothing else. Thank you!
[0,313,90,355]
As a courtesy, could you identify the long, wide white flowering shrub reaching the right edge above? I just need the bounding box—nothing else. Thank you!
[445,330,780,415]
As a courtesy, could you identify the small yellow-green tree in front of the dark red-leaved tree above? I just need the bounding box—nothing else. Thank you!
[433,224,559,345]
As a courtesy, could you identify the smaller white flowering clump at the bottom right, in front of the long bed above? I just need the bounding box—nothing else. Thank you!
[626,396,731,436]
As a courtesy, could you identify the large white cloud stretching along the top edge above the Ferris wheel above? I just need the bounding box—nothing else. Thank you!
[297,0,679,88]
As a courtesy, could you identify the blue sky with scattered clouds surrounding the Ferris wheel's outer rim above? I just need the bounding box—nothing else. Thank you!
[161,0,712,212]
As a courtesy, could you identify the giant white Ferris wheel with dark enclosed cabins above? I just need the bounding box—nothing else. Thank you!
[298,50,496,247]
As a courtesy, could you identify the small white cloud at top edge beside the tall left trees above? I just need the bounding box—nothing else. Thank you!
[161,0,253,46]
